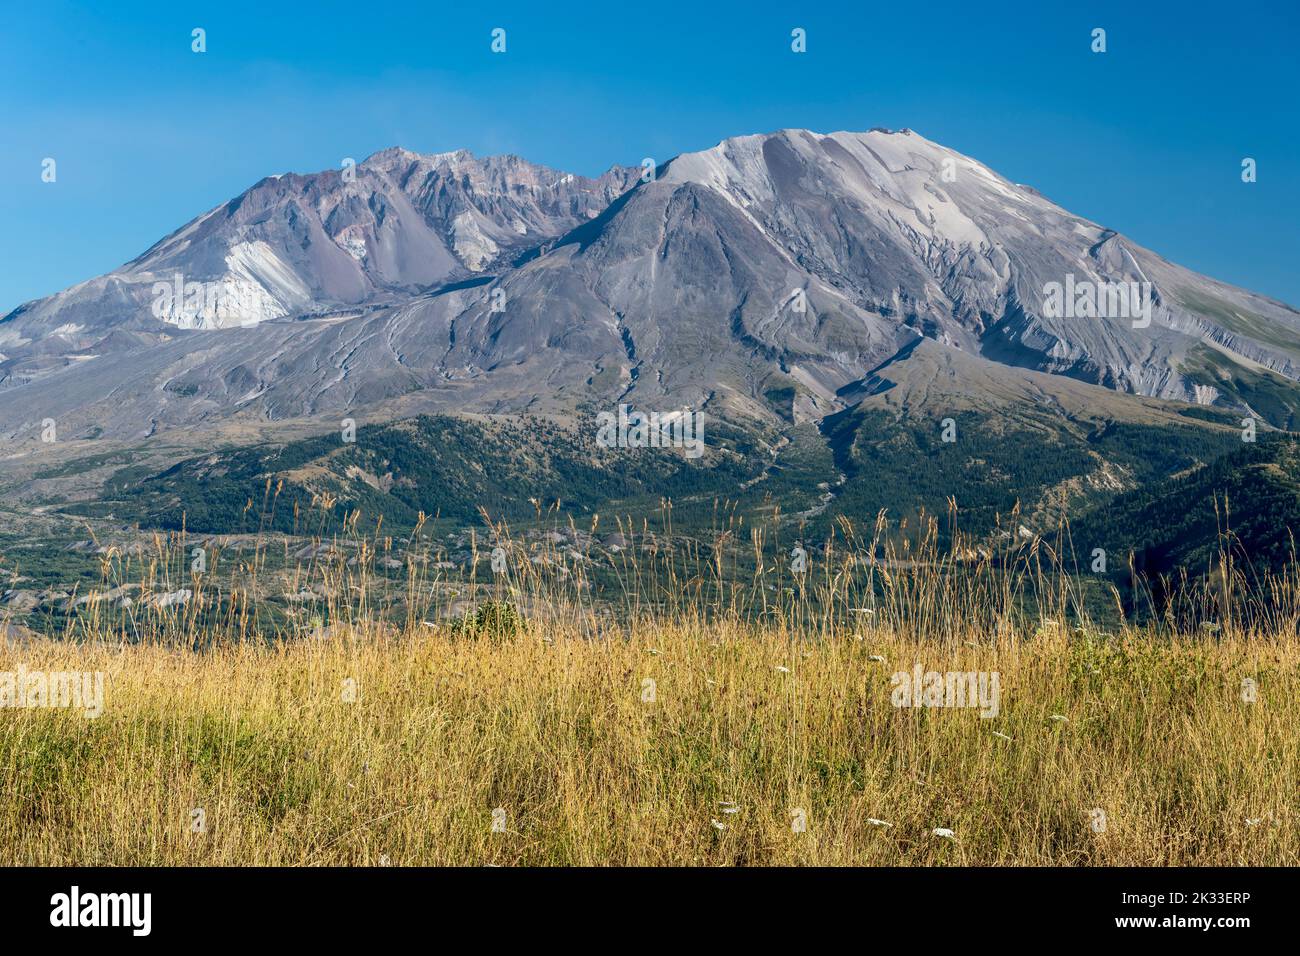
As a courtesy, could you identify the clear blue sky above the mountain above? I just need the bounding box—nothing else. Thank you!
[0,0,1300,313]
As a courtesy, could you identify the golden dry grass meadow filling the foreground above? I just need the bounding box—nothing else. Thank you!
[0,614,1300,865]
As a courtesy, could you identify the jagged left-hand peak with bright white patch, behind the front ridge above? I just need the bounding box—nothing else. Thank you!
[0,148,638,386]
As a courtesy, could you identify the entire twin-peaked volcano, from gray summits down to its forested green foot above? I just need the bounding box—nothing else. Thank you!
[0,130,1300,574]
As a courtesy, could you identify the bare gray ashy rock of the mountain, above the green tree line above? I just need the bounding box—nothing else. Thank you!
[0,130,1300,438]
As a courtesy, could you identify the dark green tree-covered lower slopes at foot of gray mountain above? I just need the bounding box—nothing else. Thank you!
[48,359,1240,548]
